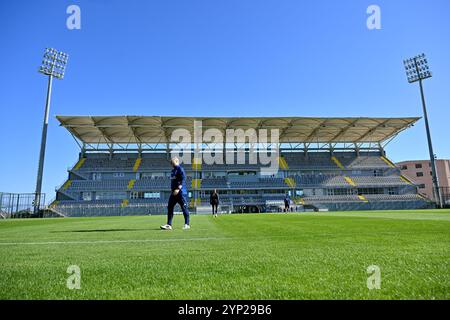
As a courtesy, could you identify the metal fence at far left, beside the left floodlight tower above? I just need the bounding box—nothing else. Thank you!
[0,192,45,219]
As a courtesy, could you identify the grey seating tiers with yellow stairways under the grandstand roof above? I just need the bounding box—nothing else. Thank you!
[53,151,430,216]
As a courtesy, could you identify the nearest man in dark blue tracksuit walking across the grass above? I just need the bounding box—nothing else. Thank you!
[161,157,191,230]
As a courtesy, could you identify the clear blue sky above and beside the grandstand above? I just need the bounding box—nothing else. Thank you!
[0,0,450,200]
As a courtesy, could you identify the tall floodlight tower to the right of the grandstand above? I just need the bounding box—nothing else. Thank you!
[403,53,442,208]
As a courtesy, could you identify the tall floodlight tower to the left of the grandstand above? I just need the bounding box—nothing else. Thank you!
[34,48,69,214]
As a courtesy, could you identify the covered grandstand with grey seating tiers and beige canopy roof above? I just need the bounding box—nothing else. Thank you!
[50,116,433,216]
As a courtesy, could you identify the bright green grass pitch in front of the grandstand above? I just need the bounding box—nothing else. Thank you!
[0,210,450,299]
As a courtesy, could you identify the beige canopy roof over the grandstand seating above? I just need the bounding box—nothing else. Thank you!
[56,116,419,144]
